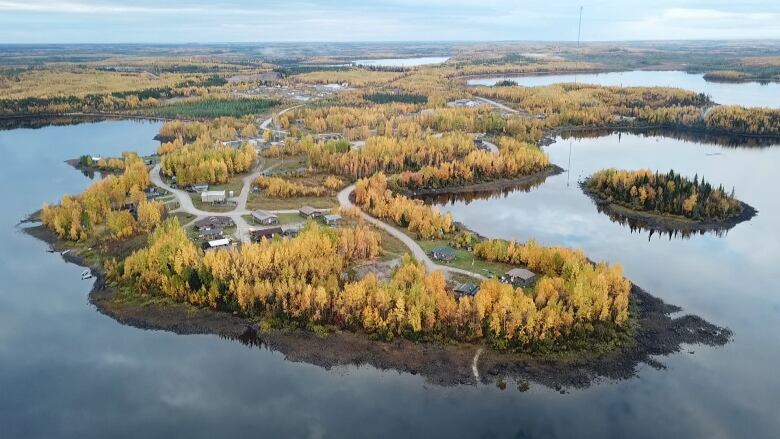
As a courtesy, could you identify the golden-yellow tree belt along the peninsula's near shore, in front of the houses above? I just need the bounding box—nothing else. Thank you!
[109,219,630,348]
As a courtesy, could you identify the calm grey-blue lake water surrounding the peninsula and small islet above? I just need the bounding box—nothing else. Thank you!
[0,122,780,439]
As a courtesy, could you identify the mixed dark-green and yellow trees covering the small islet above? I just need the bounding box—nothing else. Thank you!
[583,169,743,220]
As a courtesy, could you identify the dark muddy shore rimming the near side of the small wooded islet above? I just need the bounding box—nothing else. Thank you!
[579,181,758,233]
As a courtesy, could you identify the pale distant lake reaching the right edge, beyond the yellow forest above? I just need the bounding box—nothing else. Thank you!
[468,70,780,108]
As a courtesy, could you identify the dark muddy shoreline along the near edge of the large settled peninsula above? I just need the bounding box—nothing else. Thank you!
[22,222,732,392]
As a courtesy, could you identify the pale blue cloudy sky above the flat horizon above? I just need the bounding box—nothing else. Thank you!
[0,0,780,44]
